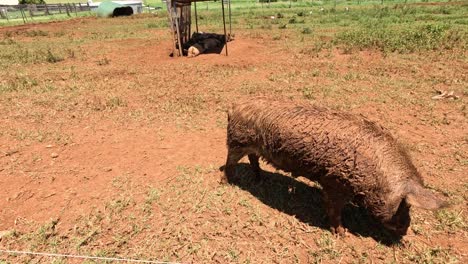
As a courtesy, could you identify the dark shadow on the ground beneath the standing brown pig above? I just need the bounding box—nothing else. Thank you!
[228,163,401,245]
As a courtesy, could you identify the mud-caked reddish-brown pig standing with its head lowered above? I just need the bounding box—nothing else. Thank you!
[222,98,447,236]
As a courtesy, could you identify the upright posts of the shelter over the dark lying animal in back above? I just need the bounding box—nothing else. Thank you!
[166,0,232,57]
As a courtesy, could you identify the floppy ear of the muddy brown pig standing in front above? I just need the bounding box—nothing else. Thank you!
[406,183,449,210]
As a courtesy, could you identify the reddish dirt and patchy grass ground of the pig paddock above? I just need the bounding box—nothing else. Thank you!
[0,1,468,264]
